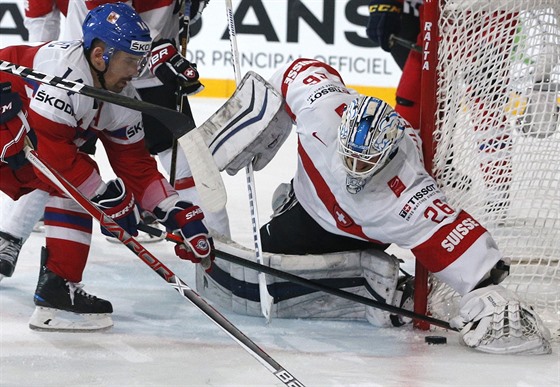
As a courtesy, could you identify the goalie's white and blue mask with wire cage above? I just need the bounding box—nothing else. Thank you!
[338,96,406,181]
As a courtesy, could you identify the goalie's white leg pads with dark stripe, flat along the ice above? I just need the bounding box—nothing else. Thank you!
[196,238,413,327]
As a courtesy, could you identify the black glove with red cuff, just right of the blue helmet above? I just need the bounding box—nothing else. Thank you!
[148,39,204,94]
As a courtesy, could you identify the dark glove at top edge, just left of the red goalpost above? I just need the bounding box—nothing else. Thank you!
[366,0,403,52]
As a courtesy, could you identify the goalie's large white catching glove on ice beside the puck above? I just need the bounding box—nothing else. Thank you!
[450,285,551,355]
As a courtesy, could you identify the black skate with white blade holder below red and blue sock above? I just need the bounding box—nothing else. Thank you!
[29,260,113,332]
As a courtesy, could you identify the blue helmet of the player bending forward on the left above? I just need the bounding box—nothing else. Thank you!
[82,2,152,67]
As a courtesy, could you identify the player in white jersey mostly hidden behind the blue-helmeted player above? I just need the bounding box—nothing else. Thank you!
[63,0,230,237]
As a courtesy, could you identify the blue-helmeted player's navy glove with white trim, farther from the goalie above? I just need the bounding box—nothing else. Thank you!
[91,178,140,236]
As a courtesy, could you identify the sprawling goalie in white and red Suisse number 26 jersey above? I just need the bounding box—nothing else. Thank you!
[197,59,551,354]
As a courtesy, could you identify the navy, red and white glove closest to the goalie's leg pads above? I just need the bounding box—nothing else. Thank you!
[154,198,214,271]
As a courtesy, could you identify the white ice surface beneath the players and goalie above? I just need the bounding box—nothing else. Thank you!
[0,99,560,387]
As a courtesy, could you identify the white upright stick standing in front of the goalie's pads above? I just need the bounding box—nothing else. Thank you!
[226,0,274,323]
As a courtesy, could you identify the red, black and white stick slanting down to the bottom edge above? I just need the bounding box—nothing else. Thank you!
[24,145,303,387]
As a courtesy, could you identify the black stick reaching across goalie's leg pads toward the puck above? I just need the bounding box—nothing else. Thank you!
[138,224,458,331]
